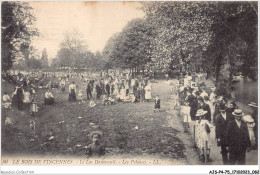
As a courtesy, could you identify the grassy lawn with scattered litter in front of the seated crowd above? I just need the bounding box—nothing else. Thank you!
[2,78,185,159]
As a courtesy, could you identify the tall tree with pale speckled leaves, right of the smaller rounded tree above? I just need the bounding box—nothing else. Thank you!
[143,2,212,71]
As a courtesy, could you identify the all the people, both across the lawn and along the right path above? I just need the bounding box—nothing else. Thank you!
[2,71,257,162]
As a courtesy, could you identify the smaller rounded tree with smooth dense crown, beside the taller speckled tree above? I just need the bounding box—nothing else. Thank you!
[103,19,153,71]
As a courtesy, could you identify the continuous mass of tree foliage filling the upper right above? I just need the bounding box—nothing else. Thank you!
[103,2,258,96]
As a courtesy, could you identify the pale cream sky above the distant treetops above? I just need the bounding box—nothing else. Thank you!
[30,1,144,59]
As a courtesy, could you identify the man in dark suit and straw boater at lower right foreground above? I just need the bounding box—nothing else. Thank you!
[226,109,251,165]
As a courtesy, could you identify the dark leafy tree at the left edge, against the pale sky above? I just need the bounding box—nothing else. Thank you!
[1,1,38,71]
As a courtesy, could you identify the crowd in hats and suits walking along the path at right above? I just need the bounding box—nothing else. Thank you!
[174,74,258,165]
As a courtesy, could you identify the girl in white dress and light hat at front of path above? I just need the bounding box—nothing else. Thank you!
[196,109,213,162]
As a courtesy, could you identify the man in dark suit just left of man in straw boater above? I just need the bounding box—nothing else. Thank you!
[216,103,233,165]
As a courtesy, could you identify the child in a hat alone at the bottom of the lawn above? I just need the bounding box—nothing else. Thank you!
[85,131,105,157]
